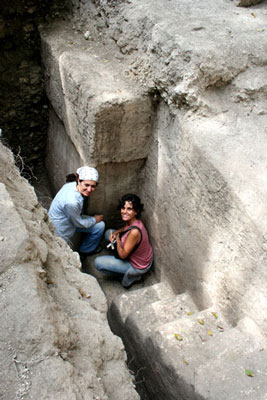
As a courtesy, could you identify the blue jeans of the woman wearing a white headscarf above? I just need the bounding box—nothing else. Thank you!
[76,221,105,253]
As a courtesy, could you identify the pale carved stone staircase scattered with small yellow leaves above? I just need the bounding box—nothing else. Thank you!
[109,282,267,400]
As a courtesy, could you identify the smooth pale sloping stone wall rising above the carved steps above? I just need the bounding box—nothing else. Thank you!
[142,97,267,331]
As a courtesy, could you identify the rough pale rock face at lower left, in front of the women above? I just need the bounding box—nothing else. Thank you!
[0,145,139,400]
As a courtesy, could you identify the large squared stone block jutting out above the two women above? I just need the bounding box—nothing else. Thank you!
[39,25,152,165]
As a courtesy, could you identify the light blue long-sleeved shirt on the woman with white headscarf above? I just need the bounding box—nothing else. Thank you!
[48,182,96,241]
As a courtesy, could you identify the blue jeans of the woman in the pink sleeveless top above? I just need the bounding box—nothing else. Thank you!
[94,229,153,287]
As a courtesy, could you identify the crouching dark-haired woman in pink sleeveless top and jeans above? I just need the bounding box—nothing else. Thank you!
[95,194,153,288]
